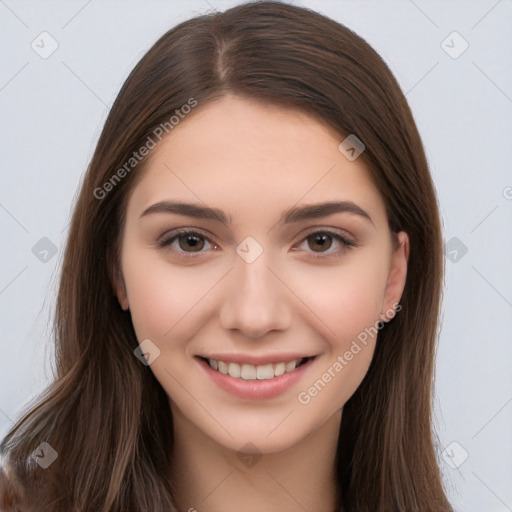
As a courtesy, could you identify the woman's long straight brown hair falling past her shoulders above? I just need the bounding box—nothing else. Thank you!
[0,2,452,512]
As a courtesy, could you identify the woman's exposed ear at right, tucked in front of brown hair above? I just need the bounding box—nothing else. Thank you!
[380,231,409,322]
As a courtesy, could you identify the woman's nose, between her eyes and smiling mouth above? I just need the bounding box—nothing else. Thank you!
[220,252,292,339]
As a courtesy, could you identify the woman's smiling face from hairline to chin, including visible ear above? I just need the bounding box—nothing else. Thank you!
[116,96,408,453]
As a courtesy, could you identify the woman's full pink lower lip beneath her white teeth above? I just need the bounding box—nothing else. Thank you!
[199,358,315,400]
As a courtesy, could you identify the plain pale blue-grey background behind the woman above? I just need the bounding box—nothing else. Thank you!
[0,0,512,512]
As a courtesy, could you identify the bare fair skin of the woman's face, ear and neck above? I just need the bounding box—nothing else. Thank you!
[115,95,409,512]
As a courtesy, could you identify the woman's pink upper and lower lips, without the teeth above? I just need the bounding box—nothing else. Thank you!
[198,355,314,400]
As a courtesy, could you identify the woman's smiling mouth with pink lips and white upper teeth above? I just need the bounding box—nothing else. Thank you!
[195,355,317,400]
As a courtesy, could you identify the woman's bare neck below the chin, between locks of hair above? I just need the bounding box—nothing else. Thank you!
[171,411,341,512]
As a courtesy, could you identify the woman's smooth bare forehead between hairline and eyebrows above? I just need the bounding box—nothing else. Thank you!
[126,96,385,226]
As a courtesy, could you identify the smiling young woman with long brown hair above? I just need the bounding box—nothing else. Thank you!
[0,2,452,512]
